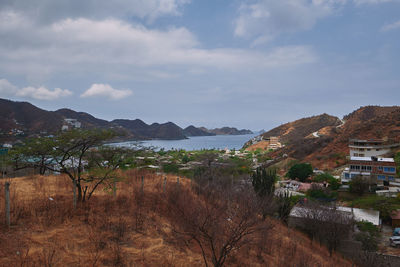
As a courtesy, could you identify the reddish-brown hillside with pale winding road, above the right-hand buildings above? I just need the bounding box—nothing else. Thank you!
[247,106,400,169]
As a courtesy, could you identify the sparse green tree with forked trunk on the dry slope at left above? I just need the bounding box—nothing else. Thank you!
[11,129,130,201]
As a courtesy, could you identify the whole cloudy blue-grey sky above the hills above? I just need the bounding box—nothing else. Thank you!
[0,0,400,130]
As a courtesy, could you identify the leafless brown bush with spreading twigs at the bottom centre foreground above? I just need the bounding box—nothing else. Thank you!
[168,184,271,266]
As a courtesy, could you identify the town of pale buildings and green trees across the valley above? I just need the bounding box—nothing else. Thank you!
[0,123,400,262]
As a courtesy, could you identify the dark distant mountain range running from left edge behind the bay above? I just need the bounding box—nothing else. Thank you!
[0,99,252,141]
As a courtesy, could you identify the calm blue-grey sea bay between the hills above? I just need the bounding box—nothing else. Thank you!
[113,134,257,151]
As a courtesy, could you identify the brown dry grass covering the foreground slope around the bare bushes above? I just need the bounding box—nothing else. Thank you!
[0,173,351,266]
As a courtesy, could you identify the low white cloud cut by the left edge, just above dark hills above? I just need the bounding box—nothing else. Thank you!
[0,79,72,100]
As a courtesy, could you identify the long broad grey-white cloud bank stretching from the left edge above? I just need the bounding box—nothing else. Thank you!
[0,11,317,80]
